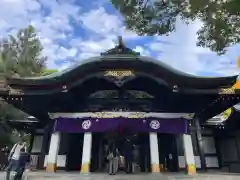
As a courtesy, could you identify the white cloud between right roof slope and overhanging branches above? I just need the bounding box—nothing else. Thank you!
[143,17,240,76]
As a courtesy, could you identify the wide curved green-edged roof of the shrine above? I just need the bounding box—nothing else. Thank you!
[5,42,237,88]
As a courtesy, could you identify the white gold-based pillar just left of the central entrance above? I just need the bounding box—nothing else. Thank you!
[81,132,92,173]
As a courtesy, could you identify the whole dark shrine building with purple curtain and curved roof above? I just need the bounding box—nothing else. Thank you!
[0,38,240,174]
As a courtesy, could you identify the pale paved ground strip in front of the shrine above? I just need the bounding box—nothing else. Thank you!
[0,172,240,180]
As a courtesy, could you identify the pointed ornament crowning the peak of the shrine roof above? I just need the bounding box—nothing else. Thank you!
[101,36,140,56]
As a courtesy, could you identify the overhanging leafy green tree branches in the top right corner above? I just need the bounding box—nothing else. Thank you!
[111,0,240,54]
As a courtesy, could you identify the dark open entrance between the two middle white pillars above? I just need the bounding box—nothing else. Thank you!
[91,128,151,173]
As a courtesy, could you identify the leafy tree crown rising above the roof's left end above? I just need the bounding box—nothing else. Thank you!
[0,26,46,77]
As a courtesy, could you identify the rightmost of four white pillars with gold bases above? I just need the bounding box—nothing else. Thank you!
[182,134,196,175]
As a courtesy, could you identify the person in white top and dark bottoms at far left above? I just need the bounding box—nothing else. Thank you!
[6,139,26,180]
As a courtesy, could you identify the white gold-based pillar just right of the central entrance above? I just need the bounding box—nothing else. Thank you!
[149,132,160,173]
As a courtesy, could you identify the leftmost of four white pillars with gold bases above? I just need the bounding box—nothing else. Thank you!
[46,132,61,172]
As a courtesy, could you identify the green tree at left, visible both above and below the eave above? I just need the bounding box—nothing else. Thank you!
[0,26,46,146]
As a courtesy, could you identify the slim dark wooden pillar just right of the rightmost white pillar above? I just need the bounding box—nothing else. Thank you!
[193,117,207,171]
